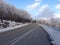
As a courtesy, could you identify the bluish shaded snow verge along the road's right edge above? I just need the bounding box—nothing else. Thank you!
[40,24,60,45]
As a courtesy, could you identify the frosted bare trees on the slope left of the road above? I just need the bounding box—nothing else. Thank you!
[0,1,32,22]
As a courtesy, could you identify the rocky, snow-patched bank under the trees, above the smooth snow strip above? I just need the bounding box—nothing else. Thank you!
[0,20,23,29]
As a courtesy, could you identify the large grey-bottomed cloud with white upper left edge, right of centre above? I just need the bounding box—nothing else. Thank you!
[37,4,54,18]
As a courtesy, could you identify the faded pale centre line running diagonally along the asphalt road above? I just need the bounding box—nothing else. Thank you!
[5,25,39,45]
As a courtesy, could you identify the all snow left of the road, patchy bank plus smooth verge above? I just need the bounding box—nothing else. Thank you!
[0,20,30,32]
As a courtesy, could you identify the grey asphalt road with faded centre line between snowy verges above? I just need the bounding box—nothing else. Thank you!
[0,23,50,45]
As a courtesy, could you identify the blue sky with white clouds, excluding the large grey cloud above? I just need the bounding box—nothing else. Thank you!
[5,0,60,18]
